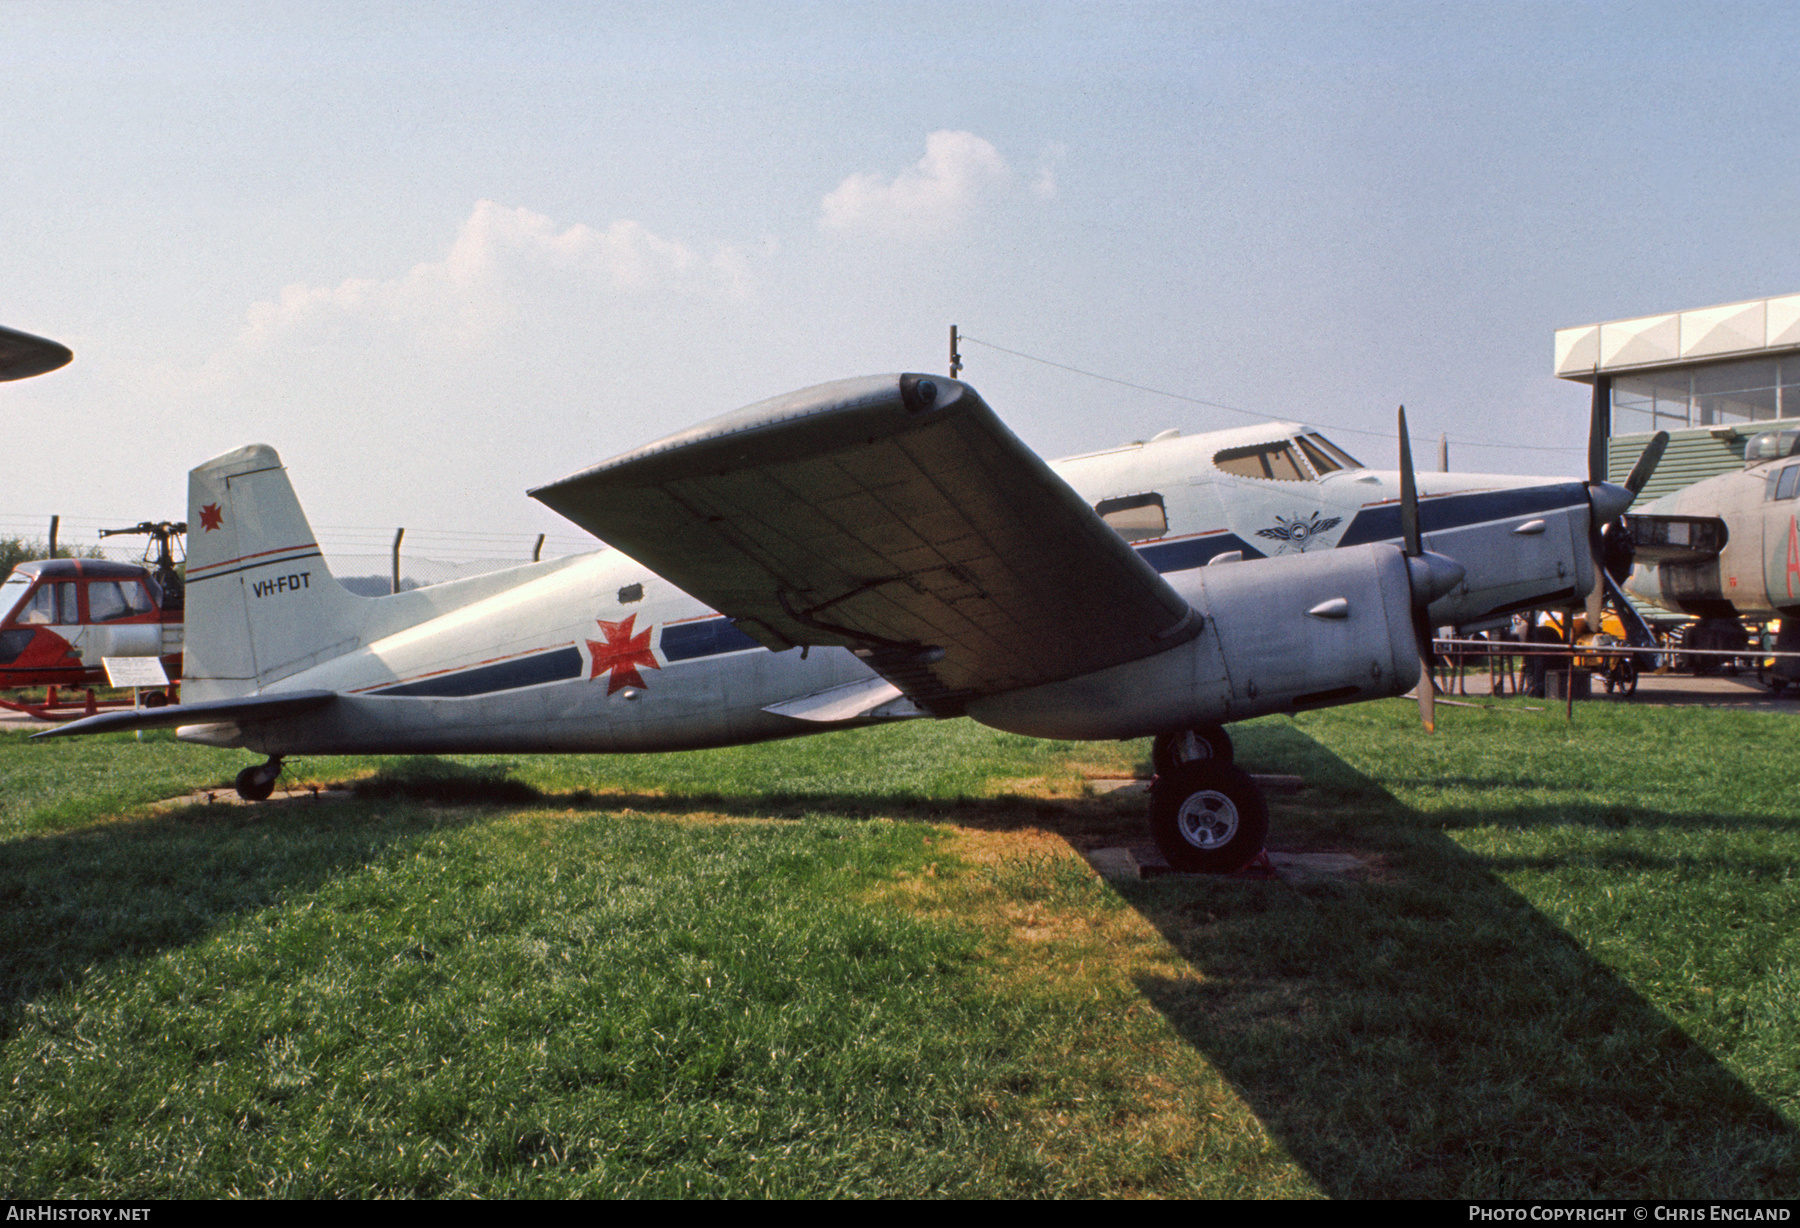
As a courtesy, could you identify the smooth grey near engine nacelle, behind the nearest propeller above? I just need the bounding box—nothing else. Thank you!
[968,542,1418,740]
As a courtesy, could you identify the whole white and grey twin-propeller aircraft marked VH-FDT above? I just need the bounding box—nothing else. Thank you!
[38,375,1629,870]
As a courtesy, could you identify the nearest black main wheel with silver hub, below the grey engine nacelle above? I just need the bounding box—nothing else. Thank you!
[1150,760,1269,873]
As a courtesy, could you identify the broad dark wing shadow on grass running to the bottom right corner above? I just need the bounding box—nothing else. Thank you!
[1125,727,1800,1197]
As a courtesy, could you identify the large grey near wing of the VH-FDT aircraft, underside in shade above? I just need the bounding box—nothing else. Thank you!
[531,375,1199,715]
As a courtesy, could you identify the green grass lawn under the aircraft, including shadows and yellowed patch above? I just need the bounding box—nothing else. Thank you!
[0,700,1800,1197]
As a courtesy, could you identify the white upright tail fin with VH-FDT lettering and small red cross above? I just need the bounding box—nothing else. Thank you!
[182,443,369,702]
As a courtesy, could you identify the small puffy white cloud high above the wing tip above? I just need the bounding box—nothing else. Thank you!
[819,131,1012,236]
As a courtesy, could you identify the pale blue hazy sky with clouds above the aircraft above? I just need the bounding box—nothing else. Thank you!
[0,0,1800,554]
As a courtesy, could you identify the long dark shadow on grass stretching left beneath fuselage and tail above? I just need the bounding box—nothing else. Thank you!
[0,756,1101,1039]
